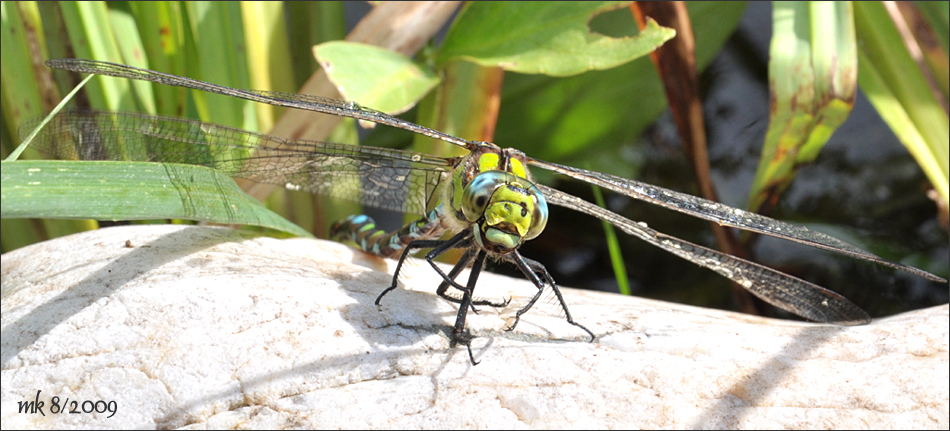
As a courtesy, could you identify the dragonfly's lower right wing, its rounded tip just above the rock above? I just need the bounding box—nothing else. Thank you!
[538,184,871,325]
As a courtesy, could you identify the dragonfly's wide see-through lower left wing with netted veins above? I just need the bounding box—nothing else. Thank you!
[20,111,454,218]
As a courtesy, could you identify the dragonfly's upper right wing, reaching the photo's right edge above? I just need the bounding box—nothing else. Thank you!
[528,159,947,283]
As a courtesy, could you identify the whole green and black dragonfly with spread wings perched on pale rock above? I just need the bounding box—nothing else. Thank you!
[21,59,947,364]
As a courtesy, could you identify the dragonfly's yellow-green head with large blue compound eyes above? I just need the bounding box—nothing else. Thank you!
[461,171,548,254]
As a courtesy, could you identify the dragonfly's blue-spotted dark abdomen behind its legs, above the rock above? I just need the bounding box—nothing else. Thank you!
[330,209,445,257]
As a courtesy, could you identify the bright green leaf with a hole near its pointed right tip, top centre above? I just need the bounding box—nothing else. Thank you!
[438,2,674,76]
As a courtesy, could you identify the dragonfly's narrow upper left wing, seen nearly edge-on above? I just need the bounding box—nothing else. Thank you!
[46,58,478,149]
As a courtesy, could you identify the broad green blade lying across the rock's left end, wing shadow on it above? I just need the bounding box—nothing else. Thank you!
[0,160,310,236]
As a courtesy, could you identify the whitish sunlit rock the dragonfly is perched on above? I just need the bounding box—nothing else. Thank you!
[2,225,950,429]
